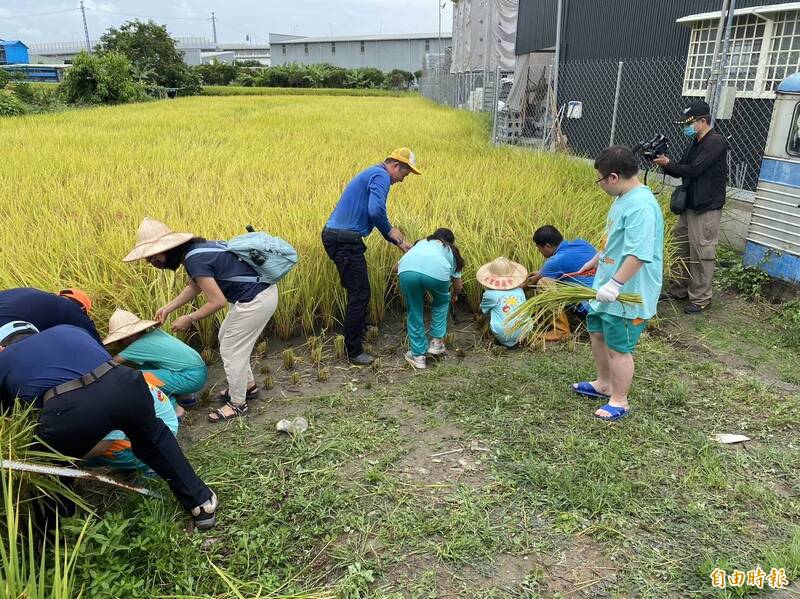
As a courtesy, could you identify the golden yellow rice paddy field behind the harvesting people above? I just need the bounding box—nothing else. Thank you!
[0,96,652,343]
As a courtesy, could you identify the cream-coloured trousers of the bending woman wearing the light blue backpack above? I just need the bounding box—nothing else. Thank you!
[218,285,278,405]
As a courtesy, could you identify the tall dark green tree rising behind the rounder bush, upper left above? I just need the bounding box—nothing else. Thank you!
[98,20,200,93]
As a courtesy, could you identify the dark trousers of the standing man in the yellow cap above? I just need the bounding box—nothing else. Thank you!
[322,229,370,358]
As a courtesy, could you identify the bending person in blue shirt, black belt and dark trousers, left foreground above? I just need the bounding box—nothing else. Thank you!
[0,321,218,529]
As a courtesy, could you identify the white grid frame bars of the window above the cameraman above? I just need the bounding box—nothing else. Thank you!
[682,10,800,99]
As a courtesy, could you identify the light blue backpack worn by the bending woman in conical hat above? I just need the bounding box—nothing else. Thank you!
[184,226,299,285]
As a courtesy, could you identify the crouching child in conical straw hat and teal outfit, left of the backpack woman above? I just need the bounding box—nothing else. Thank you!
[103,309,208,417]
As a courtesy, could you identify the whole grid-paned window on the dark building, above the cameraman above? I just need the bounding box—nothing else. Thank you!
[683,10,800,98]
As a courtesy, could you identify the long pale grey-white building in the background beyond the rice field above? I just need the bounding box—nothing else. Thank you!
[269,33,452,73]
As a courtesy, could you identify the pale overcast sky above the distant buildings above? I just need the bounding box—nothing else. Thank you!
[0,0,453,43]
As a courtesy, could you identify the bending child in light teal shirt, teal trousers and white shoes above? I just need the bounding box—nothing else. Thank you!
[397,228,464,369]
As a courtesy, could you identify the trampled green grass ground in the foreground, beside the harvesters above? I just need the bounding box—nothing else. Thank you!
[29,300,800,599]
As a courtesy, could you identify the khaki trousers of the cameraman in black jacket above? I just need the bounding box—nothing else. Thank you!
[670,210,722,306]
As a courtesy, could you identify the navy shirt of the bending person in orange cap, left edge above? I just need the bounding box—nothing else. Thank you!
[0,287,100,343]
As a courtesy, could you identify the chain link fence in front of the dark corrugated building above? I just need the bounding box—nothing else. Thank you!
[420,58,774,191]
